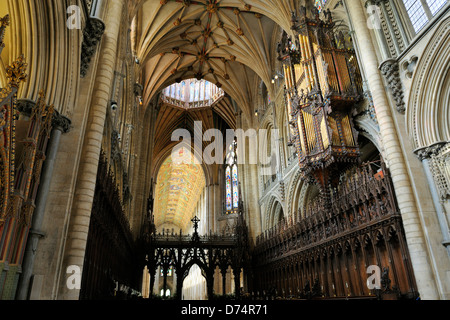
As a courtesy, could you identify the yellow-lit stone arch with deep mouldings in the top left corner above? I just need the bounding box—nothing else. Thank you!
[0,0,81,118]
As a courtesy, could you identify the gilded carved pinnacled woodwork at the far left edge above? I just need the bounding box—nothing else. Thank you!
[0,16,55,297]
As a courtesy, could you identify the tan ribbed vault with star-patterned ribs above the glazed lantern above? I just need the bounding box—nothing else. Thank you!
[132,0,297,118]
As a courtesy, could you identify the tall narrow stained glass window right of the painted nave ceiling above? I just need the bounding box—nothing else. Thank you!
[225,141,239,214]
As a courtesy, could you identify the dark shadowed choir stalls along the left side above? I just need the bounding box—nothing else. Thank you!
[80,152,141,300]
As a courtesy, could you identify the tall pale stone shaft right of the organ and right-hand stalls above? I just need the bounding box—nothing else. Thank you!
[346,0,439,299]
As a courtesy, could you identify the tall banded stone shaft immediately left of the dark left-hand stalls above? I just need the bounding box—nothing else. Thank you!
[58,0,123,300]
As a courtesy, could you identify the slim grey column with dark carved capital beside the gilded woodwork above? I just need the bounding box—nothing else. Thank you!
[16,114,71,300]
